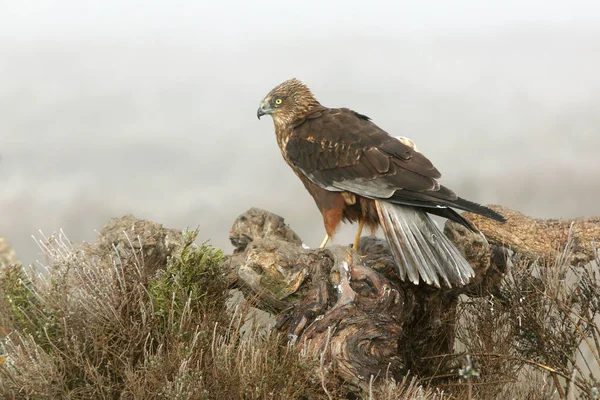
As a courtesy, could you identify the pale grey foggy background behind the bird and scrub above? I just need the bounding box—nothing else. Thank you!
[0,0,600,263]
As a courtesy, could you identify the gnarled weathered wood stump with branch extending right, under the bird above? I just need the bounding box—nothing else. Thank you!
[224,206,600,388]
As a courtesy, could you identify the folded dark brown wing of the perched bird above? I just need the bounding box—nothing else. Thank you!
[284,108,457,203]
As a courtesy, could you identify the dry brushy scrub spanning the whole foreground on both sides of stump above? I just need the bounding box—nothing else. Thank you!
[0,222,600,400]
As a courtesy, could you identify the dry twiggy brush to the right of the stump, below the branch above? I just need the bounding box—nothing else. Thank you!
[449,236,600,399]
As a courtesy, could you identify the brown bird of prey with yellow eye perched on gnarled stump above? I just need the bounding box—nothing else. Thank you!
[257,78,504,287]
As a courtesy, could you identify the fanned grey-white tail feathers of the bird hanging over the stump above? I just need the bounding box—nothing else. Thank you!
[376,201,475,287]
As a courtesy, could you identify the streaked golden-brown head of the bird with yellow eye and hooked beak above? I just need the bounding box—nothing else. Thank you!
[256,78,319,126]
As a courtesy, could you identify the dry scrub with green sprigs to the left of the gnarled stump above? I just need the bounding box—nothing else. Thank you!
[0,228,336,399]
